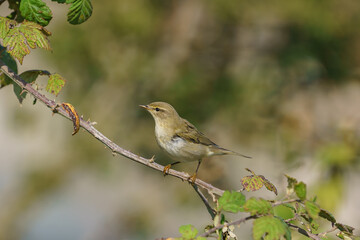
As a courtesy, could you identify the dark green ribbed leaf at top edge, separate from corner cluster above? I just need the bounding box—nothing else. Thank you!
[67,0,92,25]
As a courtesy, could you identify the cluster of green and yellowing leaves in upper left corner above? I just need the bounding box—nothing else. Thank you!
[0,0,92,103]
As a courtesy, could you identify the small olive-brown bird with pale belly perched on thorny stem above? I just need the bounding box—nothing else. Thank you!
[140,102,251,183]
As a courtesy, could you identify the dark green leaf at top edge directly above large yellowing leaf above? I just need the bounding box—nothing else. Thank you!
[20,0,52,26]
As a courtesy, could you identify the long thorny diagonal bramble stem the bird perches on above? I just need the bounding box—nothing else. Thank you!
[0,60,224,196]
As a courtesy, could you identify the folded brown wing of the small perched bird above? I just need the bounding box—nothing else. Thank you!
[175,119,217,146]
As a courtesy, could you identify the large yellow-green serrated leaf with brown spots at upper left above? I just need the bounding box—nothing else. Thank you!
[3,20,51,64]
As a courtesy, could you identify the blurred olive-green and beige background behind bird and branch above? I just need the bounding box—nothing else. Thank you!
[0,0,360,240]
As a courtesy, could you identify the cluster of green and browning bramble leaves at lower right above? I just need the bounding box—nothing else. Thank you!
[176,169,355,240]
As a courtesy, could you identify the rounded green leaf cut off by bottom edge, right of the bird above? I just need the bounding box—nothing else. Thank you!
[253,216,291,240]
